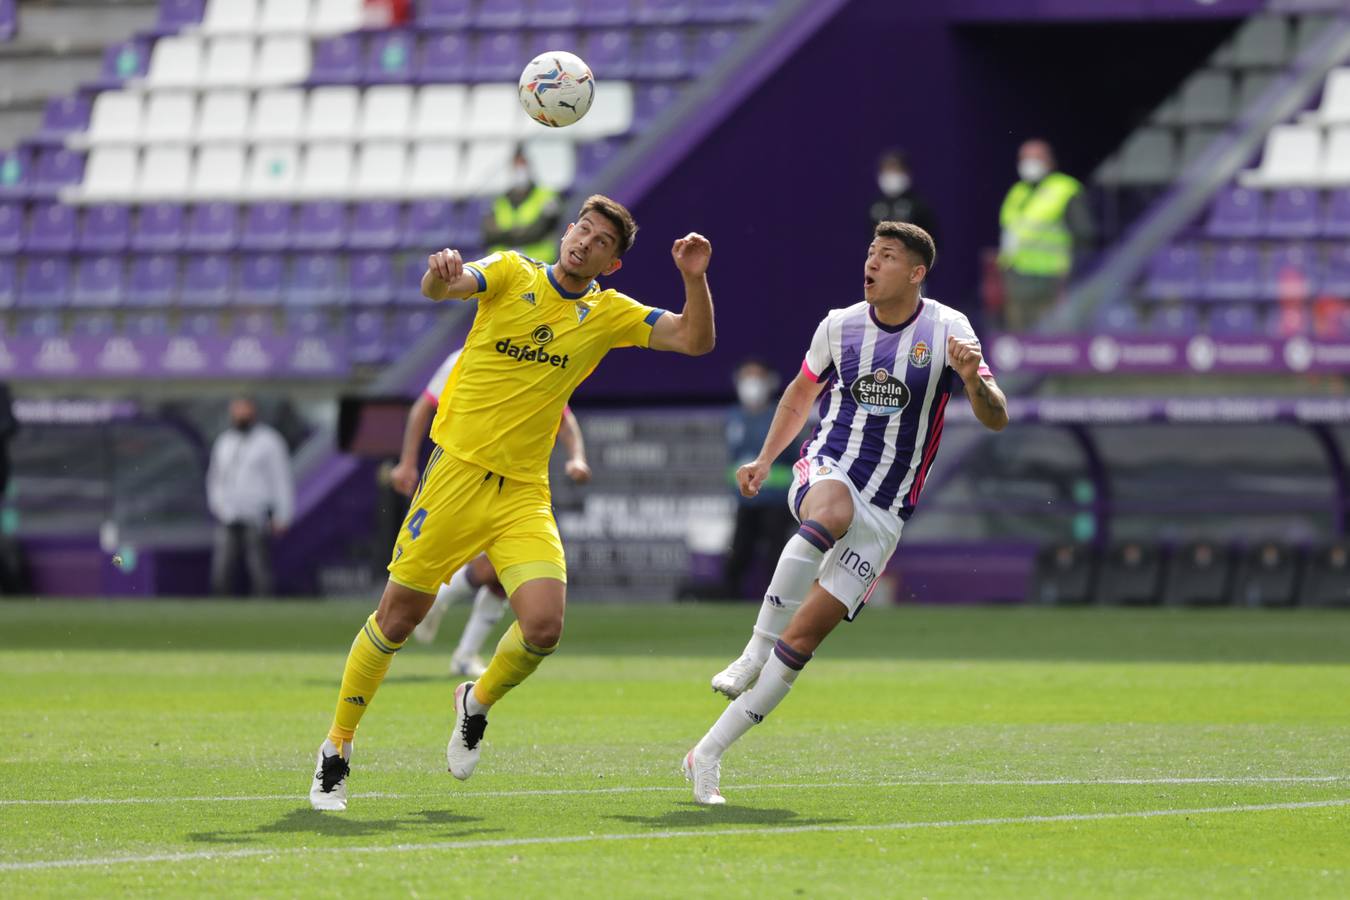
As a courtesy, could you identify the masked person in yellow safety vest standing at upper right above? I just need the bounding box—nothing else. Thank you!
[999,140,1094,332]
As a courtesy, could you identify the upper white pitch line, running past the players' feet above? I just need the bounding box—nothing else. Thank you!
[0,775,1350,807]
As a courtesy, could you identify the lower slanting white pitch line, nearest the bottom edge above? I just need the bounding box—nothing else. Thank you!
[0,797,1350,872]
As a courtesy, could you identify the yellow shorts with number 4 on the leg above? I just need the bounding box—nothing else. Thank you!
[389,447,567,596]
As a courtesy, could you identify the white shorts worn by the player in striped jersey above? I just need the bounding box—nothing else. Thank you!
[787,456,905,622]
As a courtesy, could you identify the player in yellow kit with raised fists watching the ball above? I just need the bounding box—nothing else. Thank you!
[309,194,714,810]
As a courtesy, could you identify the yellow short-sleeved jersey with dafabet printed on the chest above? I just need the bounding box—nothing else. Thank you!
[431,250,666,484]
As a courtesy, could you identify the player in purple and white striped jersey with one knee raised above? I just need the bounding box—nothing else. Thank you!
[683,221,1008,804]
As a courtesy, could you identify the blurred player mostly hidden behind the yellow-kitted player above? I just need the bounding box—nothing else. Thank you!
[389,348,590,679]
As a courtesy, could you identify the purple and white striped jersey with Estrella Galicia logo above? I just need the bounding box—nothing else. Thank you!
[802,297,988,519]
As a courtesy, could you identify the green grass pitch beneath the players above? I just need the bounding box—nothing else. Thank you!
[0,602,1350,897]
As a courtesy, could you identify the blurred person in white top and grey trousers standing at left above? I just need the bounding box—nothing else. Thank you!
[207,397,296,596]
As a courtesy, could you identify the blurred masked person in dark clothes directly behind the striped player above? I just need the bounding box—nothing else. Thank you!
[721,359,797,599]
